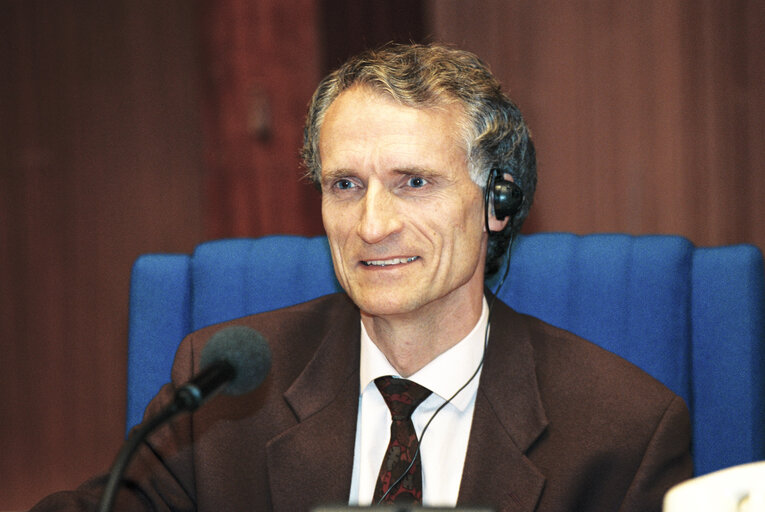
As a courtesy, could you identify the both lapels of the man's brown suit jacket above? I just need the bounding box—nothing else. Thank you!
[266,294,547,512]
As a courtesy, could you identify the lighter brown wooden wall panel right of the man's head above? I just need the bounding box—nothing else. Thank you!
[428,0,765,247]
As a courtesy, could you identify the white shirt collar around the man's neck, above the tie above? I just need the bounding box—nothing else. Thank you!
[359,297,489,409]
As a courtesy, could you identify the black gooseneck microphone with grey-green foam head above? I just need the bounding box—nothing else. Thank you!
[98,325,271,512]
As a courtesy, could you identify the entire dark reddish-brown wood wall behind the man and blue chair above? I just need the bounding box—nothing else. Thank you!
[0,0,765,510]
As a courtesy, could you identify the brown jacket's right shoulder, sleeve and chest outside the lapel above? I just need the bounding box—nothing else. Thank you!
[492,302,692,510]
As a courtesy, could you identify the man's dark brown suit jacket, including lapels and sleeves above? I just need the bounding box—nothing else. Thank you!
[35,295,692,512]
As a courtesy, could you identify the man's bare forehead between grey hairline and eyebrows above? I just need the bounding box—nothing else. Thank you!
[319,86,466,168]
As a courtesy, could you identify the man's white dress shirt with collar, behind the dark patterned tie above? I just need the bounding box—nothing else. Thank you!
[349,298,489,507]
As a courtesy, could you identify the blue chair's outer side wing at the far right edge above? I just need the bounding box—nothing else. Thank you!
[692,245,765,474]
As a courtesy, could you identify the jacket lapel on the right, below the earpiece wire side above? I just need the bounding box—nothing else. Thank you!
[459,301,547,512]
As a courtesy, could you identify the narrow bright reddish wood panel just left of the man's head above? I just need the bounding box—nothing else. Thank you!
[202,0,323,238]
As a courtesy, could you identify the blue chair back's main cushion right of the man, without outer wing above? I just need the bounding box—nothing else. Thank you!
[500,234,693,402]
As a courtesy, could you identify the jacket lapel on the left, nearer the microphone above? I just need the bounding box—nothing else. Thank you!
[266,298,360,511]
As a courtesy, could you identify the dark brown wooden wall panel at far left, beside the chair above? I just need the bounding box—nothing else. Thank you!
[0,0,204,510]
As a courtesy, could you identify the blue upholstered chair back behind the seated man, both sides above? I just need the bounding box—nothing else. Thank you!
[127,234,765,474]
